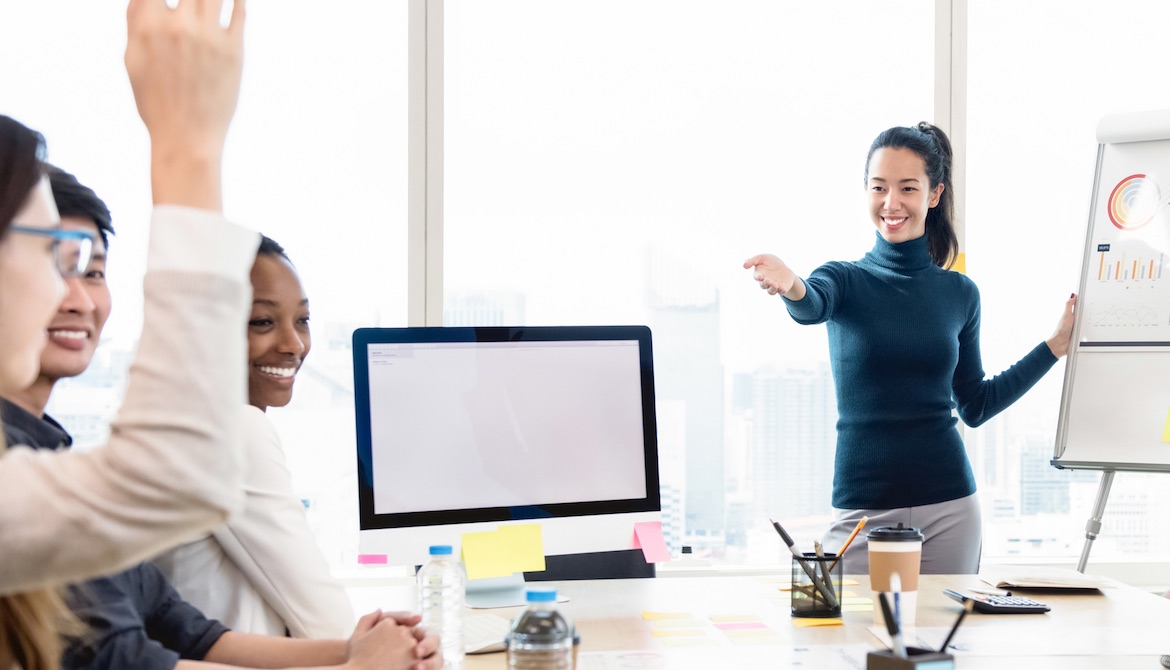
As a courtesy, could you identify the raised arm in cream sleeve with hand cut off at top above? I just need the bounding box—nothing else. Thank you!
[0,0,259,594]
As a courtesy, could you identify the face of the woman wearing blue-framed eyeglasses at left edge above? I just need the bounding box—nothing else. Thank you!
[0,179,66,394]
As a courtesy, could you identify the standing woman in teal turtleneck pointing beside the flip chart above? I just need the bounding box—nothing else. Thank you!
[743,123,1076,574]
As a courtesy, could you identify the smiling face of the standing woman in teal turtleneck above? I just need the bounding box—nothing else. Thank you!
[866,147,943,244]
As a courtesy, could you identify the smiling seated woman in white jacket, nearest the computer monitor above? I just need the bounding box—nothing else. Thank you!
[154,236,353,638]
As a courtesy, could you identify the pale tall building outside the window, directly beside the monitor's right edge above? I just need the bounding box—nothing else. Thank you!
[646,251,725,548]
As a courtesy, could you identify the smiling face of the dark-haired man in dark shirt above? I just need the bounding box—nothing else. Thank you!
[41,216,110,382]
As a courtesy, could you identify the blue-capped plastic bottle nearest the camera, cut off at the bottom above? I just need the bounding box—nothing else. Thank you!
[507,588,578,670]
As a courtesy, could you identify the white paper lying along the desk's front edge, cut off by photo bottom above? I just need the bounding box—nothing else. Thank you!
[577,643,873,670]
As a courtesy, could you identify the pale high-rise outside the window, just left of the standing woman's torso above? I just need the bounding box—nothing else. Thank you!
[751,364,837,519]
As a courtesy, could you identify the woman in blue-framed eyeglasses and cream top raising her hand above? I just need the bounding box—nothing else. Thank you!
[0,0,259,670]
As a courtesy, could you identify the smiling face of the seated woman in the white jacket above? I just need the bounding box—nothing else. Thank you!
[248,254,310,410]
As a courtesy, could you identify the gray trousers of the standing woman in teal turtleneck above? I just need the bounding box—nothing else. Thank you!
[823,493,983,574]
